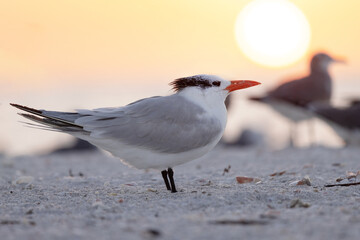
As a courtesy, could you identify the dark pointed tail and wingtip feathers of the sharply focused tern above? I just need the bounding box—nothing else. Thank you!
[10,103,84,132]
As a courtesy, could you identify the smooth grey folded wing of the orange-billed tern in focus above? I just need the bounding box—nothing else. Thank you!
[75,94,222,153]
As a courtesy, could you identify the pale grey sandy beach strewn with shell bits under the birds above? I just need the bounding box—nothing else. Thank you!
[0,147,360,240]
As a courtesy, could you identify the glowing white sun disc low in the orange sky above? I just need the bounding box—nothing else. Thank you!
[235,0,311,67]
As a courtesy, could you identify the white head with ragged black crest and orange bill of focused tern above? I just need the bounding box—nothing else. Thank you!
[170,74,260,101]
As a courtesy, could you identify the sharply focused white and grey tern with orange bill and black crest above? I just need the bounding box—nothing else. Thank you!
[11,75,260,192]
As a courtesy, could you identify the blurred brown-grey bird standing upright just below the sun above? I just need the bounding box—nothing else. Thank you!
[250,53,345,145]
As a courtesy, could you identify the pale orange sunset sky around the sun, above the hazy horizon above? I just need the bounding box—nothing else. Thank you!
[0,0,360,86]
